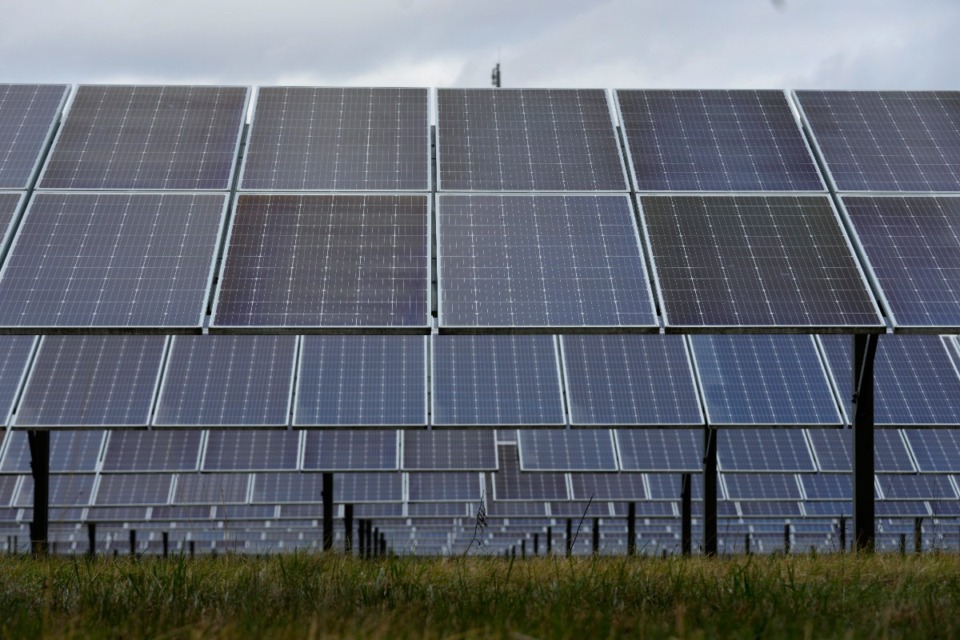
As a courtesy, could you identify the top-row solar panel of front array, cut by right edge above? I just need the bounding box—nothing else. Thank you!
[796,91,960,191]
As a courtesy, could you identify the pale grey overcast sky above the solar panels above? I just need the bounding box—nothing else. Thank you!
[0,0,960,89]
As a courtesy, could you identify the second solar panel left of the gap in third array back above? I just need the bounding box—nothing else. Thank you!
[303,430,400,471]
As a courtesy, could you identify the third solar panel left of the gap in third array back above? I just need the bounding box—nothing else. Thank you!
[202,431,300,471]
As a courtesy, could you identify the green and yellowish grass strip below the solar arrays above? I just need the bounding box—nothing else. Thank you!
[0,554,960,639]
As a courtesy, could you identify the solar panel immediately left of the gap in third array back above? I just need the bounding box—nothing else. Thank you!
[403,430,497,471]
